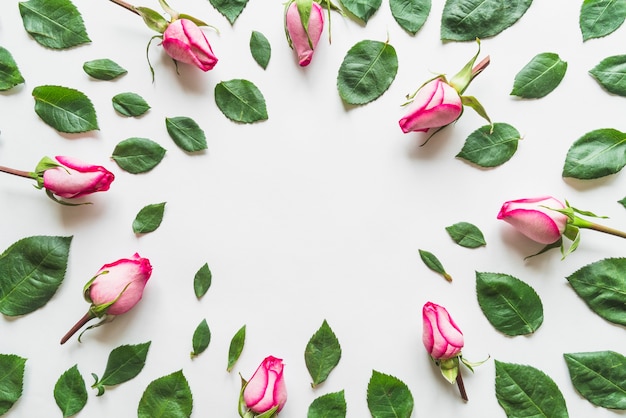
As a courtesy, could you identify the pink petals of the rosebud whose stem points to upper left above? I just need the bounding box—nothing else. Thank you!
[162,19,217,71]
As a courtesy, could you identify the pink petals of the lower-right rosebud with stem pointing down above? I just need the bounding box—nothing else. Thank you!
[422,302,463,360]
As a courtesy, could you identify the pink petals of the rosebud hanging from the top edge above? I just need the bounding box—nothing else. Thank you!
[285,2,324,67]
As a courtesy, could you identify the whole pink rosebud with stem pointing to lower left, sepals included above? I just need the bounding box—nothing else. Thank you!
[61,253,152,344]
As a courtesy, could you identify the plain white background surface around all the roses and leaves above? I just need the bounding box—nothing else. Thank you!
[0,0,626,418]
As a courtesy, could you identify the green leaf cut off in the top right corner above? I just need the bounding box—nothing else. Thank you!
[579,0,626,42]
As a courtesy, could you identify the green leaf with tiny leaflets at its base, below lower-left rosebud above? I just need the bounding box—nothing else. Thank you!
[91,341,150,396]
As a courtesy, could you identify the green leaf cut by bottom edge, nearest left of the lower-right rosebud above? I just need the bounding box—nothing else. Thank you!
[367,370,413,418]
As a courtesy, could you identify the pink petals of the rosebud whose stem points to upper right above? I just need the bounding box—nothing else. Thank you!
[399,78,463,133]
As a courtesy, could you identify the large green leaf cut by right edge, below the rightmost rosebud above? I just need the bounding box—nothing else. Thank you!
[567,258,626,326]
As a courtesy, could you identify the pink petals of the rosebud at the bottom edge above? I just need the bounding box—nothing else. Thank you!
[243,356,287,414]
